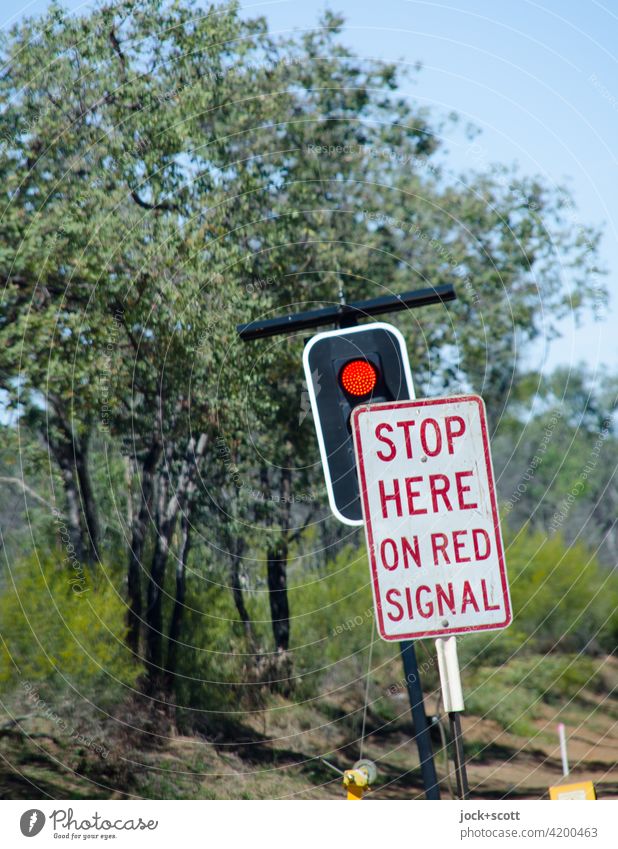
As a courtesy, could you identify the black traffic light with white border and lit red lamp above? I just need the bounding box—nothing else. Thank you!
[303,323,414,525]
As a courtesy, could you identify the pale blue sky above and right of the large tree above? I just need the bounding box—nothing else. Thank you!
[0,0,618,370]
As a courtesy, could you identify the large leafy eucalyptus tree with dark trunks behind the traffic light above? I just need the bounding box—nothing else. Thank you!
[0,0,603,687]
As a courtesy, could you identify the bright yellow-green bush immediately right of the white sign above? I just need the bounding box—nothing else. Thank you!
[452,529,618,735]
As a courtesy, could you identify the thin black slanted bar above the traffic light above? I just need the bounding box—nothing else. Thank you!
[236,283,457,342]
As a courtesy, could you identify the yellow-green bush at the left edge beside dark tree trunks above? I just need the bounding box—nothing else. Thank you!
[0,551,140,704]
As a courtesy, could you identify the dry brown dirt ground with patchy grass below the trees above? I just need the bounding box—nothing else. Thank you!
[0,658,618,800]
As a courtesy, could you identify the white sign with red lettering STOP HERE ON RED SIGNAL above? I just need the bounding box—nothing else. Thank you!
[352,395,512,640]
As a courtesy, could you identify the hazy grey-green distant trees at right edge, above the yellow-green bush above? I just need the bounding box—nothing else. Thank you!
[493,366,618,567]
